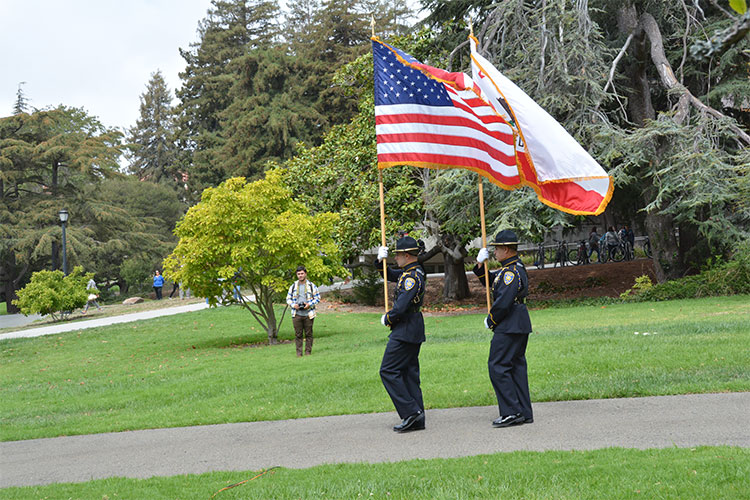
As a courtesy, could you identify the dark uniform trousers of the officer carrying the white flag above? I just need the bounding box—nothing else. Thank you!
[487,333,534,418]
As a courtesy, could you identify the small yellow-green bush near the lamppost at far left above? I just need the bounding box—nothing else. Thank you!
[13,266,94,319]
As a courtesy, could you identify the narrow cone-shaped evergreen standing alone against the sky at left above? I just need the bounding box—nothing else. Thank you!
[128,71,182,190]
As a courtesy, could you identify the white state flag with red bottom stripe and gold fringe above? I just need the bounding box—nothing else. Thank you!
[469,37,614,215]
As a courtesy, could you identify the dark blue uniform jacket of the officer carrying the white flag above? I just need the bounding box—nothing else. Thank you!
[474,256,531,333]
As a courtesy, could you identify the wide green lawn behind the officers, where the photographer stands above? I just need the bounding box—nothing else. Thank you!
[0,296,750,441]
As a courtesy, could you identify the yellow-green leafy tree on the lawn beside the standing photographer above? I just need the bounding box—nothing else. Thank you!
[164,172,345,343]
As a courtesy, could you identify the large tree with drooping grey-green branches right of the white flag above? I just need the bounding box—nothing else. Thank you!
[425,0,750,280]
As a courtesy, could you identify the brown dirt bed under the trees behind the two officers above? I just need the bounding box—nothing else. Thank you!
[318,259,656,314]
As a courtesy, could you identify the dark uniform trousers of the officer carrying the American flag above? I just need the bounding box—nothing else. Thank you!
[380,339,424,419]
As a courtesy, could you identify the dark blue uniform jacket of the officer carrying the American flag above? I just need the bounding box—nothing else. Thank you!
[380,262,427,344]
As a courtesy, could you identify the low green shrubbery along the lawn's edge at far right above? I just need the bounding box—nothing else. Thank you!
[621,245,750,302]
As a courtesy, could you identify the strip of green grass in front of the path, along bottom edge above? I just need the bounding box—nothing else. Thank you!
[0,447,750,500]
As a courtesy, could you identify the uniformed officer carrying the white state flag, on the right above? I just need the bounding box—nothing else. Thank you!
[474,229,534,427]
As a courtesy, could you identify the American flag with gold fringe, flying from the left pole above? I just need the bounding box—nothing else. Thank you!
[372,39,521,189]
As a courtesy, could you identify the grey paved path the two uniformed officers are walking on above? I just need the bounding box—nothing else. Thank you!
[0,392,750,487]
